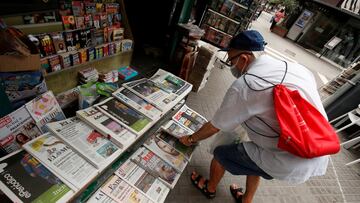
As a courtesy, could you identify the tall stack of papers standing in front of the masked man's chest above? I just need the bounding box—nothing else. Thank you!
[188,46,216,92]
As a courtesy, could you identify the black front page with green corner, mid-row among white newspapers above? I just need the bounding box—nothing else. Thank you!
[96,98,152,135]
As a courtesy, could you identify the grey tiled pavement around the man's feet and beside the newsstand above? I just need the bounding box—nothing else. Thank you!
[166,68,360,203]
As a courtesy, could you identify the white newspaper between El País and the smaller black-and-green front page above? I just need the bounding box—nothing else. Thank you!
[76,107,137,151]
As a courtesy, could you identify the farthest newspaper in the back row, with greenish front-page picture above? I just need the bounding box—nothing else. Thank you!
[150,69,192,96]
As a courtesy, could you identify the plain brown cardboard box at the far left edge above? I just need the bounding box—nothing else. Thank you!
[0,54,41,72]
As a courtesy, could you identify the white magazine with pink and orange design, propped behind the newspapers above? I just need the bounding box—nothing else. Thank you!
[25,91,66,133]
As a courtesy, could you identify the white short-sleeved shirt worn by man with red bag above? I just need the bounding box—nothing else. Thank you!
[211,55,329,183]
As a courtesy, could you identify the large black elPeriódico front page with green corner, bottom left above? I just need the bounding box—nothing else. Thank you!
[0,150,74,203]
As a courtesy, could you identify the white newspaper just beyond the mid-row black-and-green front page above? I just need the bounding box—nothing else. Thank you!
[113,87,163,121]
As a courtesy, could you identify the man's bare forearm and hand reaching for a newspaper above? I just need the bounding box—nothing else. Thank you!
[179,122,220,146]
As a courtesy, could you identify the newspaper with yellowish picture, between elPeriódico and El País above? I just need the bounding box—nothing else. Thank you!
[23,133,98,191]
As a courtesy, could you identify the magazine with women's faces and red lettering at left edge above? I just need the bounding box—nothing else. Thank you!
[0,107,41,157]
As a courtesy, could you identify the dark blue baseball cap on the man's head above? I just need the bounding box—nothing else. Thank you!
[220,30,267,51]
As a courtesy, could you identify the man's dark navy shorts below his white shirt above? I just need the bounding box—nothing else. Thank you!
[214,144,273,180]
